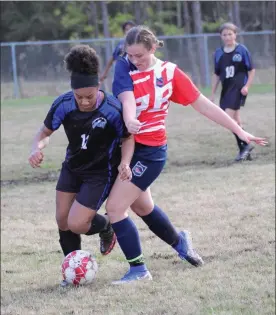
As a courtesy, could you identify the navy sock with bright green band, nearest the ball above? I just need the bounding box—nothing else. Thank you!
[112,217,144,266]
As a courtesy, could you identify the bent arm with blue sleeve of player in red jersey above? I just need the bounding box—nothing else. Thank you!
[113,58,141,134]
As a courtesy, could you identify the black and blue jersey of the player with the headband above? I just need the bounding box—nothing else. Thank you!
[44,91,127,172]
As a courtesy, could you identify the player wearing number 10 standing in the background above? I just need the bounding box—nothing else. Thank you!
[211,23,255,161]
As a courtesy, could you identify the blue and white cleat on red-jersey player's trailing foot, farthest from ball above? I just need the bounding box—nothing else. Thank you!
[178,231,204,267]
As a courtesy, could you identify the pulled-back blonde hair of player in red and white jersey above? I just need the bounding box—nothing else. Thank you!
[125,25,164,50]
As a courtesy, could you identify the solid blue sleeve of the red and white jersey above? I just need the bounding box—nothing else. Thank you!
[113,57,134,97]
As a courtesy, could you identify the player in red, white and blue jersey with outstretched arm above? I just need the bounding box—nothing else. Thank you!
[106,26,266,284]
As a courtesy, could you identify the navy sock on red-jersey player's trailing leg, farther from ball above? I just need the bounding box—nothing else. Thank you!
[141,205,180,247]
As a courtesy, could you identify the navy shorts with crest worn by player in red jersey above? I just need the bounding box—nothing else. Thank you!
[130,143,167,191]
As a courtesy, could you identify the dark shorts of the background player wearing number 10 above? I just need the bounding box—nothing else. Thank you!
[220,87,246,110]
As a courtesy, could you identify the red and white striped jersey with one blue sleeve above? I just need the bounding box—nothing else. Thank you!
[113,56,200,146]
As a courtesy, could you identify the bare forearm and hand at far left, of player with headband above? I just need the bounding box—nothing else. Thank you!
[29,124,54,168]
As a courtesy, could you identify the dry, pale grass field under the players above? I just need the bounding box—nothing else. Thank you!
[1,93,275,315]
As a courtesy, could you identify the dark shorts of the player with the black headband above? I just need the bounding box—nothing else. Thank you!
[56,162,118,210]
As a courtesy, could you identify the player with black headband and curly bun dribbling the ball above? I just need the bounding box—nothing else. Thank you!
[29,45,134,286]
